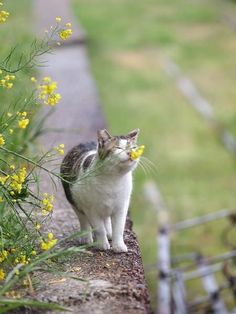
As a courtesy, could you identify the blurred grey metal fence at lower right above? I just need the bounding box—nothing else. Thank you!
[145,182,236,314]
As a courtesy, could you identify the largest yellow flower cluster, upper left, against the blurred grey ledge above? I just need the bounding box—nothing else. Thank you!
[37,76,61,106]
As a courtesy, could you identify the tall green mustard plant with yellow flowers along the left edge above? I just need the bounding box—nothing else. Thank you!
[0,2,83,313]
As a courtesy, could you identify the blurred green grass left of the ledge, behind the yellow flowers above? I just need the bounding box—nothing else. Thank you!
[0,0,36,152]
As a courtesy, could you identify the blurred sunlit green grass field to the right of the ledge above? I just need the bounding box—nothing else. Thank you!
[74,0,236,310]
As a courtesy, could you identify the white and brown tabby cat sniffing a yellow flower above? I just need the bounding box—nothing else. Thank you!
[61,129,139,252]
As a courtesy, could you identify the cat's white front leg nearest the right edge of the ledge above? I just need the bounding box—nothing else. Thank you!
[111,203,128,253]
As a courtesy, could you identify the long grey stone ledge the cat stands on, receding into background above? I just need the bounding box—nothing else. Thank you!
[32,0,151,314]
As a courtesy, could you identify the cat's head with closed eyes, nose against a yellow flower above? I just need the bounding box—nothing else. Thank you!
[97,129,139,172]
